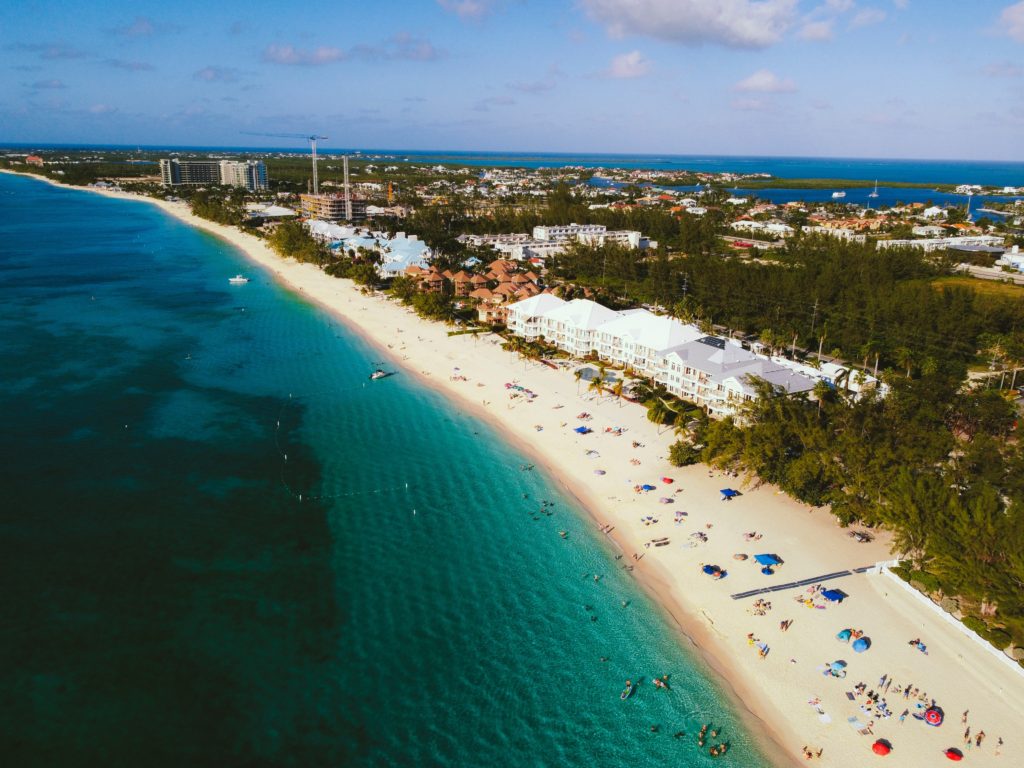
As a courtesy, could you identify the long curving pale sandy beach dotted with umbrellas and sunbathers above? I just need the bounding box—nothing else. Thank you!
[9,169,1024,768]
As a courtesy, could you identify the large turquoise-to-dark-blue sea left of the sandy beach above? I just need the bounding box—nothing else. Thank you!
[0,175,767,768]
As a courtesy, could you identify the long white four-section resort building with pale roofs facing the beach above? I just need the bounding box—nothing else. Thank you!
[508,294,828,417]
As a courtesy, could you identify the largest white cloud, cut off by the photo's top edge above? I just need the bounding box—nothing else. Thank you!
[580,0,798,48]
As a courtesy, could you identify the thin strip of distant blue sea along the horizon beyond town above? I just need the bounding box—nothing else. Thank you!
[14,144,1024,187]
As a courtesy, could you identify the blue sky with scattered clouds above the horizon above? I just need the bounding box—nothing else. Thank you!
[0,0,1024,161]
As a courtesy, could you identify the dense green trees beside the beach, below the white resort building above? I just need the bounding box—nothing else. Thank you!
[671,376,1024,648]
